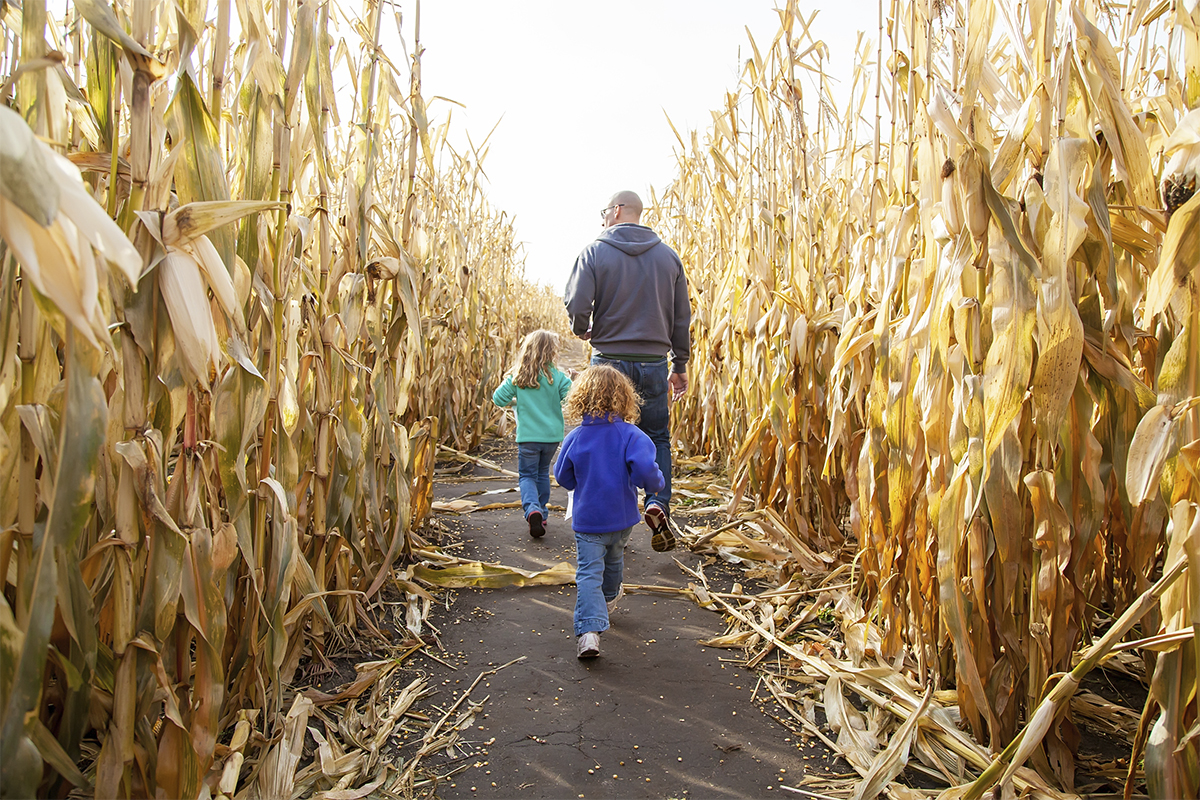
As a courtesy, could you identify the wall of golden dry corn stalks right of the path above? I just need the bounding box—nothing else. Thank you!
[658,0,1200,796]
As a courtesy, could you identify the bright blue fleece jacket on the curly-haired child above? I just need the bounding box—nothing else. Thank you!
[554,416,666,534]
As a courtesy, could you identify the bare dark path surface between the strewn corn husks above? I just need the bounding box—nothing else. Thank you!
[409,445,841,799]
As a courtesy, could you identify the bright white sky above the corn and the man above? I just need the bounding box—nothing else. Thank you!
[403,0,878,290]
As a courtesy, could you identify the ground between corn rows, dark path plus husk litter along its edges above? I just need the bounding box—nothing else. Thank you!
[281,440,1144,800]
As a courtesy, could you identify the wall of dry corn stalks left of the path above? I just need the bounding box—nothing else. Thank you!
[0,0,562,798]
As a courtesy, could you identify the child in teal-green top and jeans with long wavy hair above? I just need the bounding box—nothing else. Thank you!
[492,330,571,539]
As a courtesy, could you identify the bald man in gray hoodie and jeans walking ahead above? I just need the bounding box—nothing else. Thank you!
[564,192,691,552]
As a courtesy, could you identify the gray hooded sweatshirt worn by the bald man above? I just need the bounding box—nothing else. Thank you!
[563,222,691,372]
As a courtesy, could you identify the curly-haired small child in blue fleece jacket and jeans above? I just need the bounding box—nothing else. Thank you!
[554,365,666,658]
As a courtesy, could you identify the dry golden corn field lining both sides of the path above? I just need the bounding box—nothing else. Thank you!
[0,0,1200,798]
